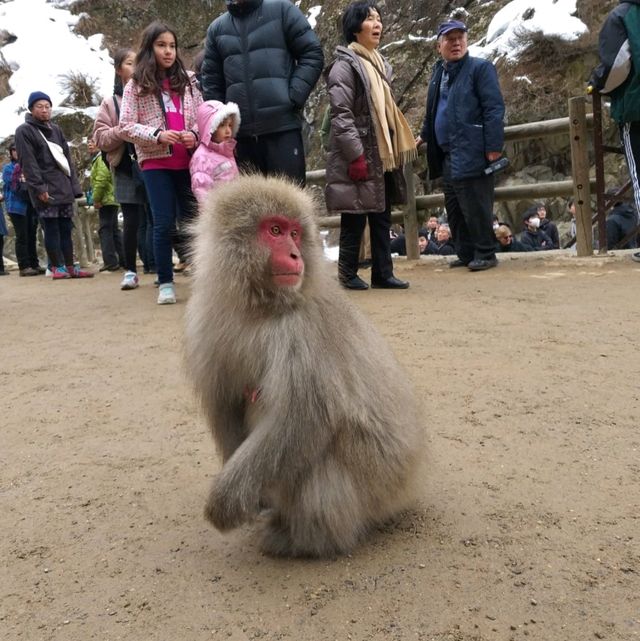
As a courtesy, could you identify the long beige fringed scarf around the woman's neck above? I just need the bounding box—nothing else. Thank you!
[349,42,418,171]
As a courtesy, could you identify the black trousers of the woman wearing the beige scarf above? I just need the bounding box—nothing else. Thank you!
[338,173,393,282]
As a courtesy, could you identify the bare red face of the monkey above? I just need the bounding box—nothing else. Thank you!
[258,215,304,287]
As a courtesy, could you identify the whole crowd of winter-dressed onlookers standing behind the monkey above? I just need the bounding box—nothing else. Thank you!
[0,0,640,284]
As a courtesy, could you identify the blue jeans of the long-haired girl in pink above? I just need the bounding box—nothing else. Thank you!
[142,169,198,285]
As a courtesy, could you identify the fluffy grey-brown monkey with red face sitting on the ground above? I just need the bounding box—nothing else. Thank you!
[186,176,423,557]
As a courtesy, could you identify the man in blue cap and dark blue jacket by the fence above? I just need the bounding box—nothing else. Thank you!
[416,20,504,271]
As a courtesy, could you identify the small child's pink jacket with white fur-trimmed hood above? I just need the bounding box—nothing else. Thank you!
[189,100,240,203]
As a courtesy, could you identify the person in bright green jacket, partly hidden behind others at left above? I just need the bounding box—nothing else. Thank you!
[89,140,124,272]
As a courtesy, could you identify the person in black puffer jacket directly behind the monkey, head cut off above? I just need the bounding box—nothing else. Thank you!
[202,0,324,185]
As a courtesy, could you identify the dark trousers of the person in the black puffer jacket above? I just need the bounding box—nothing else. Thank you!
[236,129,306,187]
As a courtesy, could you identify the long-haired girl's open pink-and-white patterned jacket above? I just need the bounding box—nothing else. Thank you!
[120,72,202,165]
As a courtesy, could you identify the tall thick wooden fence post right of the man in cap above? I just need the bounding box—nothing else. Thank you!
[569,97,593,256]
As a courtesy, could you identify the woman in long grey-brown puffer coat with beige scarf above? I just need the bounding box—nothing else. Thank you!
[325,1,417,289]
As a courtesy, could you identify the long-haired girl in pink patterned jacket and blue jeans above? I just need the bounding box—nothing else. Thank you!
[120,22,202,305]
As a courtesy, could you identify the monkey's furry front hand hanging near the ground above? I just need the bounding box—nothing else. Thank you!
[204,470,260,532]
